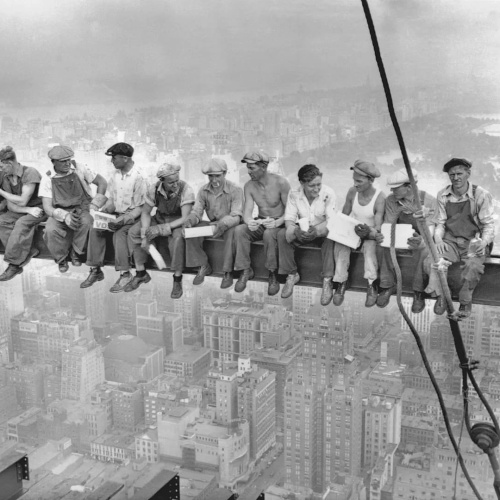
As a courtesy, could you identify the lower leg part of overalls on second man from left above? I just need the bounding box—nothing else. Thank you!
[43,211,94,264]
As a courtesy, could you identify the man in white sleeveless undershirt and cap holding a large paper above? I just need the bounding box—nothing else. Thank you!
[333,160,385,307]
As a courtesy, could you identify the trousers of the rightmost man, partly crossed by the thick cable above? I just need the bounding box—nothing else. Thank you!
[425,235,490,304]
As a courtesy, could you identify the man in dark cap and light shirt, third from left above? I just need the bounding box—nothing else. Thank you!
[80,142,146,293]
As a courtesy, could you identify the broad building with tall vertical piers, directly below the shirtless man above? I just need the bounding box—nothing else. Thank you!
[203,296,290,366]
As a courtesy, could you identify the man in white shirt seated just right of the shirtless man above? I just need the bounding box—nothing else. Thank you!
[278,164,336,305]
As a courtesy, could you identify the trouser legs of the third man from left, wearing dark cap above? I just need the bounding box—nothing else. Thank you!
[87,221,136,271]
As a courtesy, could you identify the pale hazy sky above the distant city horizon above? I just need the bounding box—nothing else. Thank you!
[0,0,500,103]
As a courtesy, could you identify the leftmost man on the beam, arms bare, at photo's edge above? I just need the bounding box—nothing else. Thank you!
[0,146,47,281]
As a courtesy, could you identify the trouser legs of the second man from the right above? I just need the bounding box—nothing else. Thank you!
[377,246,429,292]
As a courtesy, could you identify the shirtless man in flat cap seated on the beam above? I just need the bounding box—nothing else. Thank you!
[234,151,290,295]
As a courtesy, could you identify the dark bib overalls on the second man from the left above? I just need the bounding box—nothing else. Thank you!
[44,172,94,263]
